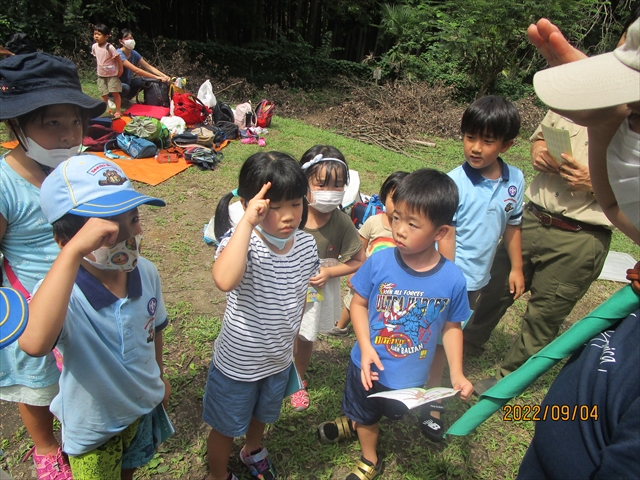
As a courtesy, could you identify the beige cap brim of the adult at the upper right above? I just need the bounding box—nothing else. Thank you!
[533,53,640,111]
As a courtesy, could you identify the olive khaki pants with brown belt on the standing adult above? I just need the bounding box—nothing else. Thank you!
[464,208,611,378]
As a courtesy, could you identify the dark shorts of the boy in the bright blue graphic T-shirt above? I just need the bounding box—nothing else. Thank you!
[342,360,409,425]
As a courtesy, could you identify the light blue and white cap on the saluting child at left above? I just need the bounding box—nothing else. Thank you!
[40,155,166,223]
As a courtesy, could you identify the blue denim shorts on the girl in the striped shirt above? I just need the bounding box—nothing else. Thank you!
[202,362,289,437]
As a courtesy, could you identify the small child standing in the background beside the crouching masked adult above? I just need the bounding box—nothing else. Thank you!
[91,23,122,118]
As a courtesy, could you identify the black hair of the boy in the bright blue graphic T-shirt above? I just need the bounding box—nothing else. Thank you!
[391,168,458,227]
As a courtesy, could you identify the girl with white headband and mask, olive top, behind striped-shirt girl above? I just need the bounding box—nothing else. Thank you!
[291,145,364,412]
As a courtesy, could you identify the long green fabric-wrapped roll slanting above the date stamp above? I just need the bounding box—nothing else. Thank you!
[445,285,640,436]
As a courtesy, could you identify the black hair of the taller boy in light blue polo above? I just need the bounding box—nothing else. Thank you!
[460,95,520,142]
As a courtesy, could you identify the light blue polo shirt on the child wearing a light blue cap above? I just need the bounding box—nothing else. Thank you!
[45,257,168,455]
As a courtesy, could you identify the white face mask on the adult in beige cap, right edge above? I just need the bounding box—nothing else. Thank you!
[607,119,640,229]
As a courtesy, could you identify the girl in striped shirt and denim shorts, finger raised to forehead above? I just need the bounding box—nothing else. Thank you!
[202,152,319,480]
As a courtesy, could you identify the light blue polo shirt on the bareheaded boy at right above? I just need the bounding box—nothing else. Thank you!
[448,158,524,292]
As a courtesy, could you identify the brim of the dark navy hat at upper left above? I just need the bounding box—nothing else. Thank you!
[0,88,107,120]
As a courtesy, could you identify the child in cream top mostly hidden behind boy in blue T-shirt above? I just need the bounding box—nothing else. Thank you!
[329,172,409,335]
